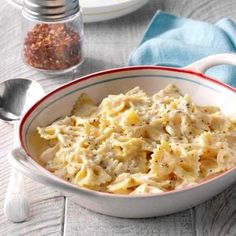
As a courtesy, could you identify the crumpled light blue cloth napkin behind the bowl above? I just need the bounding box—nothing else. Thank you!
[129,11,236,87]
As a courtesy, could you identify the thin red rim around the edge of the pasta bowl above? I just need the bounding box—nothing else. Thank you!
[19,66,236,198]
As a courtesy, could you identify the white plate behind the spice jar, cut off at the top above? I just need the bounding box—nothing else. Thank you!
[7,0,148,23]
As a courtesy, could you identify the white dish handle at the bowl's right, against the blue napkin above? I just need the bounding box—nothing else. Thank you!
[183,53,236,73]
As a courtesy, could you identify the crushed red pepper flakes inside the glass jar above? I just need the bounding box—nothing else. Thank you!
[24,23,82,70]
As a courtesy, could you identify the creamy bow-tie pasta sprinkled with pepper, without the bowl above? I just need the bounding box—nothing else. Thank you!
[38,85,236,195]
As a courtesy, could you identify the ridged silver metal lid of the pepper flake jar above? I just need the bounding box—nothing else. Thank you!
[23,0,80,21]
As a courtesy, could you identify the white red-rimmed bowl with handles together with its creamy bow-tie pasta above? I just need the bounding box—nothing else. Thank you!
[8,54,236,218]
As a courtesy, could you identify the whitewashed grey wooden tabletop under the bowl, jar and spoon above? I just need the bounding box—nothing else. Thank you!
[0,0,236,236]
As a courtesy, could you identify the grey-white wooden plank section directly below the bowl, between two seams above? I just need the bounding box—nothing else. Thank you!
[65,198,192,236]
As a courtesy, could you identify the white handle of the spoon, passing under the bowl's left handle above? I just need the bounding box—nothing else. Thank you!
[4,122,30,222]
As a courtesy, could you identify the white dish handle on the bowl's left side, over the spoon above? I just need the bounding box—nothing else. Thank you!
[8,148,86,194]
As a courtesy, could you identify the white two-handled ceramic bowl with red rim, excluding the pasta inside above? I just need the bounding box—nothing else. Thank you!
[9,54,236,218]
